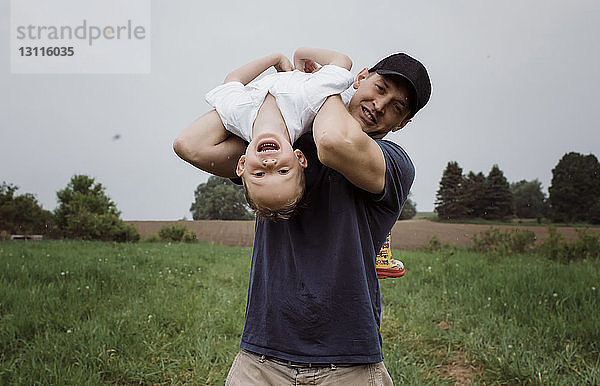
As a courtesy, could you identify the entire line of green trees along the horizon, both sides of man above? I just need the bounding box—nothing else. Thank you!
[0,152,600,241]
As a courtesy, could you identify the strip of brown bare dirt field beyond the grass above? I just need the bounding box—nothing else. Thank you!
[126,220,600,249]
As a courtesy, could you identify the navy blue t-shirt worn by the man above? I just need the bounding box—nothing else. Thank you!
[240,133,414,363]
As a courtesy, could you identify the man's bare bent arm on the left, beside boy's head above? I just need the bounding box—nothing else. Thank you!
[173,110,246,178]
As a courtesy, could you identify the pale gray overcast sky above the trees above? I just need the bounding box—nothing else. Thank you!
[0,0,600,220]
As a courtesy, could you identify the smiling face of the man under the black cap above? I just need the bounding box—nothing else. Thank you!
[348,69,412,138]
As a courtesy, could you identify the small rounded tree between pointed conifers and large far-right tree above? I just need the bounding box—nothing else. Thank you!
[510,179,547,218]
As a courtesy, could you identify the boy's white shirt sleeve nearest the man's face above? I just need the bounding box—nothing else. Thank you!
[304,64,354,114]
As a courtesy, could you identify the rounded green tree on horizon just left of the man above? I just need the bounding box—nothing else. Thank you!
[190,176,254,220]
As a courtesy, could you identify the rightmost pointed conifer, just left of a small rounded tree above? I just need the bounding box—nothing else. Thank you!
[484,165,512,220]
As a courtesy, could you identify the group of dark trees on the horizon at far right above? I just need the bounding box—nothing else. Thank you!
[435,152,600,224]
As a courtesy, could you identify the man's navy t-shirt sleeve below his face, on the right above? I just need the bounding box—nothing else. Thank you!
[374,140,415,215]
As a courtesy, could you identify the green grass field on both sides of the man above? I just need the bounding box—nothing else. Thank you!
[0,241,600,385]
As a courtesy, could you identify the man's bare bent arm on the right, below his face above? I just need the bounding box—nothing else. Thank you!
[313,95,386,193]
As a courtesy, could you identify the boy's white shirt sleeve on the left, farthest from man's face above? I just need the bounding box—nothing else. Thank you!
[205,82,253,142]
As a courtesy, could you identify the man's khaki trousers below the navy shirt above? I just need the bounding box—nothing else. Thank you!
[225,350,394,386]
